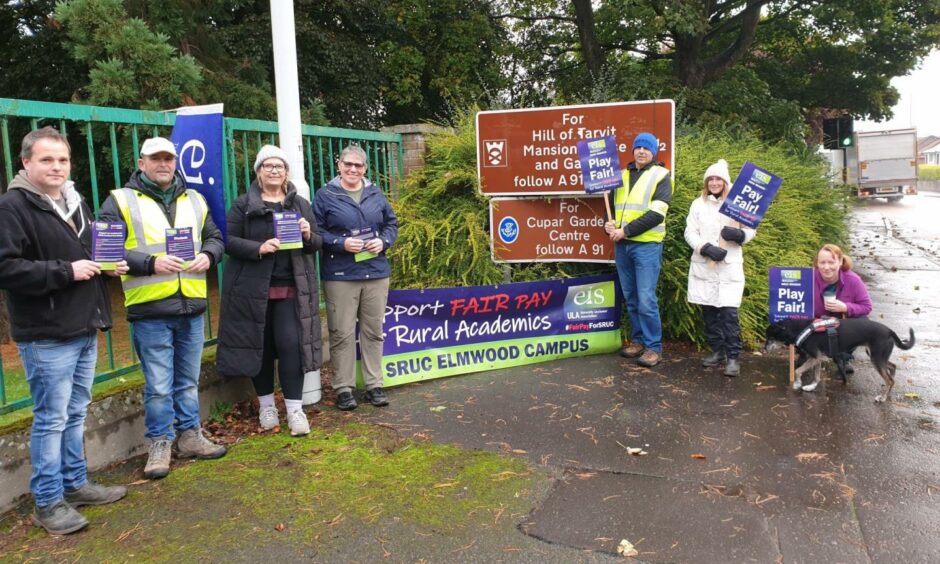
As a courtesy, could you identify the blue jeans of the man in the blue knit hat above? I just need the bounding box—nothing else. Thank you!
[614,242,663,353]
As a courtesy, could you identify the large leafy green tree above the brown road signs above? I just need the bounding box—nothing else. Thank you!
[497,0,940,138]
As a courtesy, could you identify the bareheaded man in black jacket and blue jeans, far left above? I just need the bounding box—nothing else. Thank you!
[0,127,127,534]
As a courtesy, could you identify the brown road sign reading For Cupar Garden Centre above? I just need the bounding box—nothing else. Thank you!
[490,196,614,263]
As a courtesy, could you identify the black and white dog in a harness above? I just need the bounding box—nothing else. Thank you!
[767,318,914,402]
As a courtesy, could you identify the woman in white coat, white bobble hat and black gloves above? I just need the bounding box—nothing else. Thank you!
[685,159,754,376]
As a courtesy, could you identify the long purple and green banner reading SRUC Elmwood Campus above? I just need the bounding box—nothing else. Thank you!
[368,274,621,386]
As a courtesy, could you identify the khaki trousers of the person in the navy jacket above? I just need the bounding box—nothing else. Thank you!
[324,278,389,393]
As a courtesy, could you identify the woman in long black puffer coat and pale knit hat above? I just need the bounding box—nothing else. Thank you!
[216,145,323,436]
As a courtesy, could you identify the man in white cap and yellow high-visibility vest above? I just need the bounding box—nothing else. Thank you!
[100,137,226,479]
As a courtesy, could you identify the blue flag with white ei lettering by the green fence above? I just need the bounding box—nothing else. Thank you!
[170,104,226,241]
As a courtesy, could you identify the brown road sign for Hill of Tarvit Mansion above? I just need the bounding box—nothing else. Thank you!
[477,100,675,196]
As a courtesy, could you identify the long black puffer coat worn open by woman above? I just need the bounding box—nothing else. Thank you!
[216,182,323,377]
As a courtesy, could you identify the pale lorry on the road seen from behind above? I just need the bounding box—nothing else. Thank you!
[846,128,917,201]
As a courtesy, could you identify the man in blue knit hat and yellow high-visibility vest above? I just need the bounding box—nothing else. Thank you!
[604,133,672,367]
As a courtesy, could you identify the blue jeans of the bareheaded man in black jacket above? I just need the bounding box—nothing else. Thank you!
[16,332,98,507]
